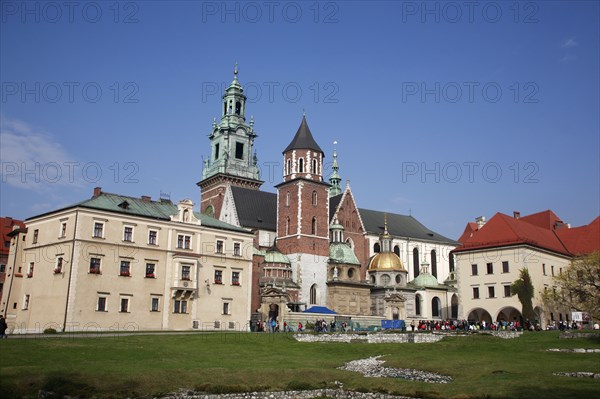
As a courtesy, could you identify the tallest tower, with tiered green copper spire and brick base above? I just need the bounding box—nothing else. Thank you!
[198,64,263,218]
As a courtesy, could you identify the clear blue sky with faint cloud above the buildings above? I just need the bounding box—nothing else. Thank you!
[0,0,600,239]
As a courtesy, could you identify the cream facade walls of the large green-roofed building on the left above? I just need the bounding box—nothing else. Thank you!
[2,209,252,331]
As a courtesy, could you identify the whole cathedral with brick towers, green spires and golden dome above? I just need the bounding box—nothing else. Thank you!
[198,66,459,321]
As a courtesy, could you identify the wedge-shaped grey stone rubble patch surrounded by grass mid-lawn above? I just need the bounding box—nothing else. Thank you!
[339,356,452,384]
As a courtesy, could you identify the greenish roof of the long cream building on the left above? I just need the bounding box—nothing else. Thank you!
[27,193,249,233]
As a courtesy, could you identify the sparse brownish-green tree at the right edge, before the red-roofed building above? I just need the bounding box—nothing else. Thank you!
[543,252,600,320]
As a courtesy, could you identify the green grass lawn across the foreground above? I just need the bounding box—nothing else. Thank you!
[0,331,600,399]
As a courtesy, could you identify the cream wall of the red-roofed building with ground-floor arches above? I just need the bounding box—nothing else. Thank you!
[456,246,569,327]
